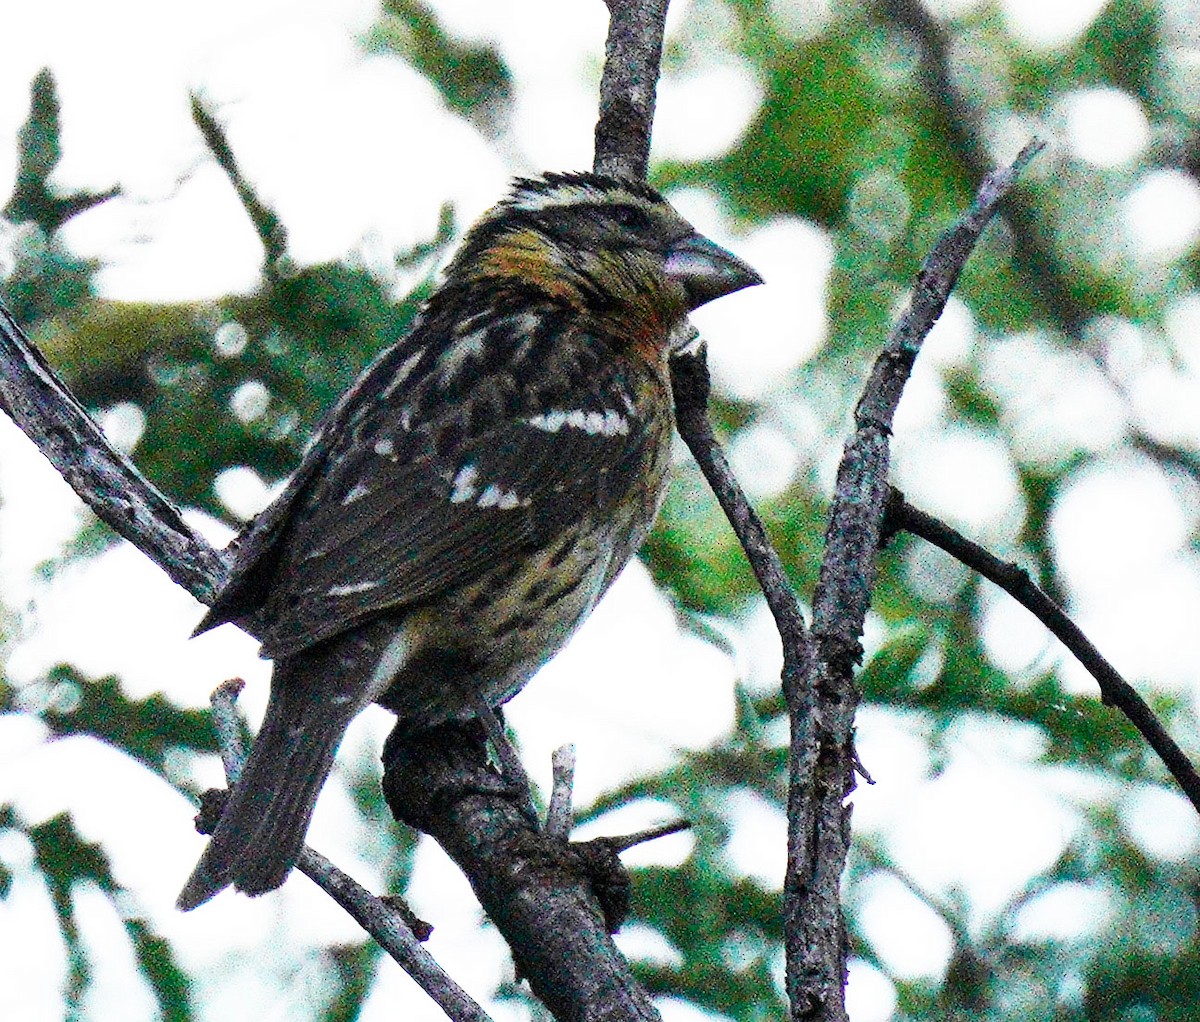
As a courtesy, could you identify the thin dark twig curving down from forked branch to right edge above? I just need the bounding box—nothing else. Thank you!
[884,489,1200,812]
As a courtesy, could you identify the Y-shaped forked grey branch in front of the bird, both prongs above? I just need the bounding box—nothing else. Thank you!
[657,103,1042,1022]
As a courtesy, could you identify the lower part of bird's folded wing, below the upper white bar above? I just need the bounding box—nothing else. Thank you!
[253,398,653,656]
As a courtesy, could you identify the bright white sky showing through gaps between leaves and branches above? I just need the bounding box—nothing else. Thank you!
[0,0,1200,1022]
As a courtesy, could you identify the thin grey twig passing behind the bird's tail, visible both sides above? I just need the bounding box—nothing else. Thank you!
[211,678,492,1022]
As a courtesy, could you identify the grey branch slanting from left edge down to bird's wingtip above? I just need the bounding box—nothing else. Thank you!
[0,306,224,603]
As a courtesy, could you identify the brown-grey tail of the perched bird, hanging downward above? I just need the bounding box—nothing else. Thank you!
[176,661,360,912]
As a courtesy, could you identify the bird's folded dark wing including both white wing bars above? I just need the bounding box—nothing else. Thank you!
[196,323,666,657]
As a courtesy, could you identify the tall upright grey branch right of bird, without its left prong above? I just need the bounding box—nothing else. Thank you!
[784,142,1043,1022]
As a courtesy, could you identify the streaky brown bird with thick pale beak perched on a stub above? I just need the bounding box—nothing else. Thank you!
[179,174,760,909]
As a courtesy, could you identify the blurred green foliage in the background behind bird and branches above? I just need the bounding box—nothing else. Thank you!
[0,0,1200,1022]
